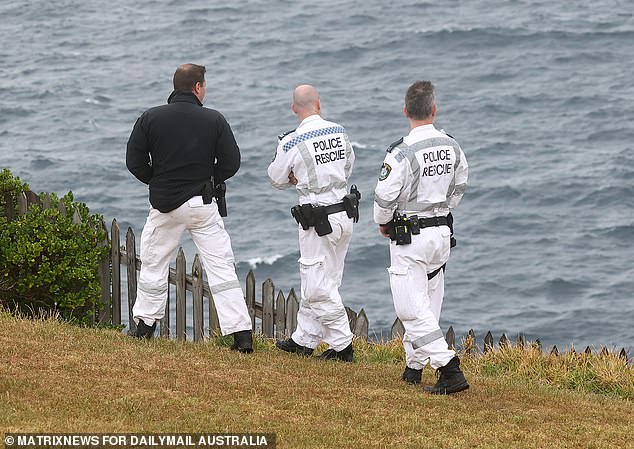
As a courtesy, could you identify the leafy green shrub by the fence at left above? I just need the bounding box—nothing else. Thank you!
[0,169,109,324]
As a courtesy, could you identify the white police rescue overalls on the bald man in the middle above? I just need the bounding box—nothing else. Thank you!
[268,115,354,351]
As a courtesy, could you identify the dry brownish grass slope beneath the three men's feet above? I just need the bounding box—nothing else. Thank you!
[0,313,634,449]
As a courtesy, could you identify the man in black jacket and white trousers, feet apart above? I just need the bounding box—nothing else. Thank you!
[126,64,253,352]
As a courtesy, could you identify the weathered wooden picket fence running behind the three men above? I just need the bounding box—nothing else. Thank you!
[4,191,628,360]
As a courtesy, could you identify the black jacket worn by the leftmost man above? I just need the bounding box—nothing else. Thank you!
[126,92,240,212]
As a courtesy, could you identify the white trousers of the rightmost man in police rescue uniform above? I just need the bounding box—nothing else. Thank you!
[388,226,456,369]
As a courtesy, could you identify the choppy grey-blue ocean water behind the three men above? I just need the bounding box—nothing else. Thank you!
[0,0,634,349]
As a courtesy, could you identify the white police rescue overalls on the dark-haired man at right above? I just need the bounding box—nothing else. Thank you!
[374,125,468,369]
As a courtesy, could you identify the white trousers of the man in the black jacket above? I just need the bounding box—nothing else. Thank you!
[132,196,251,335]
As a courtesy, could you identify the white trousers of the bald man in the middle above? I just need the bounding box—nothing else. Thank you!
[291,212,352,351]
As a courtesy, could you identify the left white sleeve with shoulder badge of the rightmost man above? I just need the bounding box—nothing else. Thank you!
[374,150,409,224]
